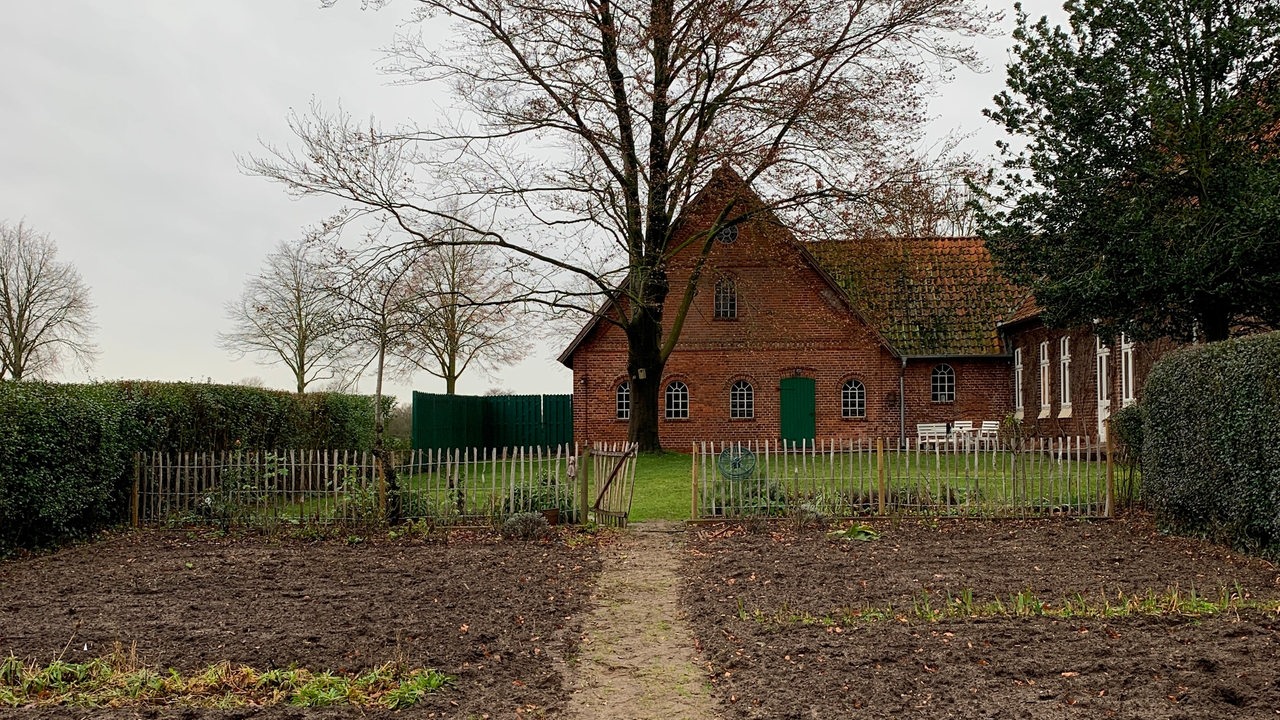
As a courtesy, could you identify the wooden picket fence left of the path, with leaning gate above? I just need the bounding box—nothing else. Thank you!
[132,445,635,527]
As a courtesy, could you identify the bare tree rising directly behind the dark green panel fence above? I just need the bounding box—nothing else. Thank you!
[410,215,529,395]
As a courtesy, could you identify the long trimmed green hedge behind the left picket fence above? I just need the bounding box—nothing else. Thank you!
[0,382,394,555]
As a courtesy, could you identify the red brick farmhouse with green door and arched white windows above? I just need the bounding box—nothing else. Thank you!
[559,169,1158,448]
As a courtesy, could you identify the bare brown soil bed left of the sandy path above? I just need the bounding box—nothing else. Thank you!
[0,532,600,720]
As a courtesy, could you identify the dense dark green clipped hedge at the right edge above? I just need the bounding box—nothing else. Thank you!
[1142,333,1280,555]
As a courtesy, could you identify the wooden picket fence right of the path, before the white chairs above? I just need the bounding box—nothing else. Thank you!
[691,437,1115,519]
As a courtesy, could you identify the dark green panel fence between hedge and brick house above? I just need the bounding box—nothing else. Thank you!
[411,392,573,450]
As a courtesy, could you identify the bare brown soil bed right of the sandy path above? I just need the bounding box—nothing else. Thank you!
[684,518,1280,719]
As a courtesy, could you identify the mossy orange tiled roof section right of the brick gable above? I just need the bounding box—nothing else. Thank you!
[801,237,1028,356]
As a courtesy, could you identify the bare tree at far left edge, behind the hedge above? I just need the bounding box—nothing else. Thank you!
[0,222,97,380]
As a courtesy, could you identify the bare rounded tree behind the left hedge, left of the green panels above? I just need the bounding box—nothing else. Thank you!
[218,240,346,393]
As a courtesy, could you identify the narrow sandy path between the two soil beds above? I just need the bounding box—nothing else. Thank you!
[568,521,717,720]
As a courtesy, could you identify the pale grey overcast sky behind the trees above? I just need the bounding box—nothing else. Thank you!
[0,0,1056,401]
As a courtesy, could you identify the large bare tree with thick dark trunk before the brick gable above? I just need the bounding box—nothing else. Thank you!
[244,0,993,450]
